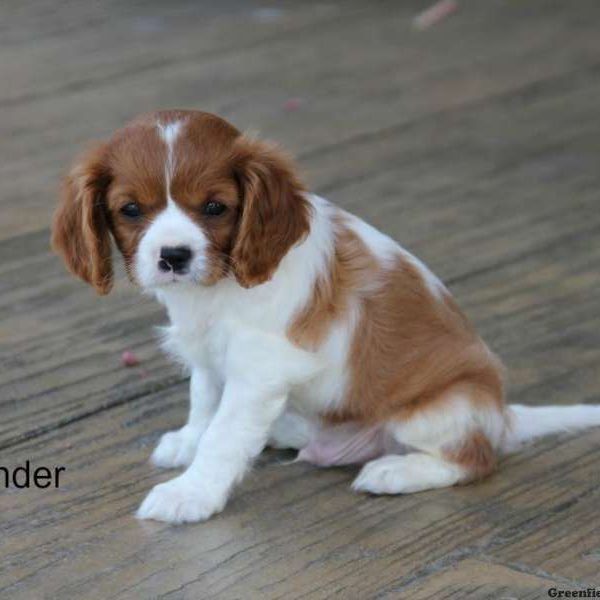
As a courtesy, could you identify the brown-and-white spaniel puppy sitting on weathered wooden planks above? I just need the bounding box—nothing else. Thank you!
[52,110,600,523]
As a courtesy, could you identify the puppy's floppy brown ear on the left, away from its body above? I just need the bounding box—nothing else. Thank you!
[52,145,113,294]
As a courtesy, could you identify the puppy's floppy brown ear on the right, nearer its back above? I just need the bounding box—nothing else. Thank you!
[231,137,310,287]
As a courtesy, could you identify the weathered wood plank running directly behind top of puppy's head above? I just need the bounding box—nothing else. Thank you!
[0,3,598,237]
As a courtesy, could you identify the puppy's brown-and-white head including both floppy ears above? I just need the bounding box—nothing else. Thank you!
[52,111,309,294]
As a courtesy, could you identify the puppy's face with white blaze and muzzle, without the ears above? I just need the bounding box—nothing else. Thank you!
[106,115,242,288]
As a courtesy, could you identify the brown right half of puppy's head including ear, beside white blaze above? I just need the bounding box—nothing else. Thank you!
[163,113,310,287]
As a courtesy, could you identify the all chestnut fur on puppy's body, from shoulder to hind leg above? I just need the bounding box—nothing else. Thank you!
[288,217,503,479]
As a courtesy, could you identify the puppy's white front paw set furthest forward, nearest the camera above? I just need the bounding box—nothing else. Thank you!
[136,474,225,524]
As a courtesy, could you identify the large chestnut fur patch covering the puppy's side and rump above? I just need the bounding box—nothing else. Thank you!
[340,256,502,421]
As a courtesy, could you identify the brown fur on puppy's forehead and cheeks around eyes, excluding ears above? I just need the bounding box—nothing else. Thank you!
[103,110,240,284]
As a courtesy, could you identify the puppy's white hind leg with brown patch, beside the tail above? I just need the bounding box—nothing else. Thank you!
[352,390,505,494]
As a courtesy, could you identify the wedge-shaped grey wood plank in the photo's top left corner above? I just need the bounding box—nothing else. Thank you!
[0,0,372,107]
